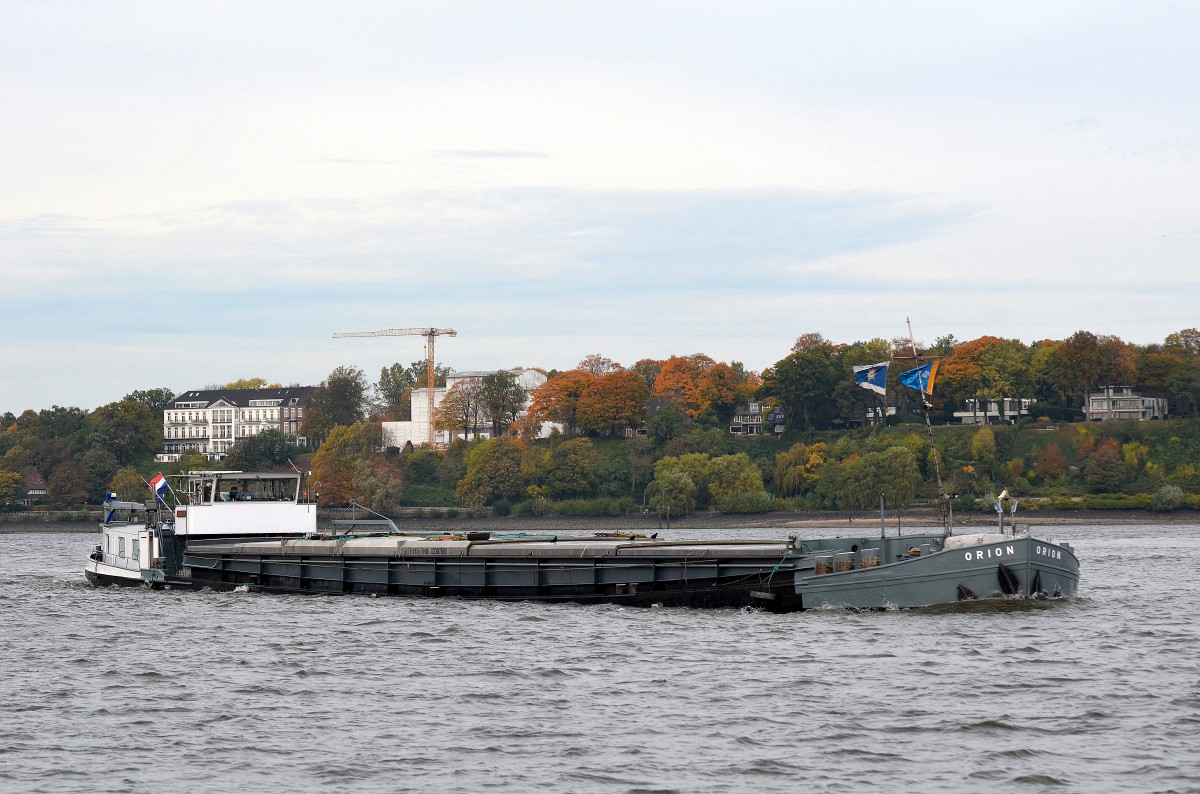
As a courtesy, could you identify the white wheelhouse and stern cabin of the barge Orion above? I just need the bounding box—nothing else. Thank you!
[84,471,317,585]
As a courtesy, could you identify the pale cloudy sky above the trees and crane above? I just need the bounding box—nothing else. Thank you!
[0,0,1200,414]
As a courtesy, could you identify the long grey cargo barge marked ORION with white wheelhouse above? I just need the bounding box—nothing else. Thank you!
[85,473,1079,612]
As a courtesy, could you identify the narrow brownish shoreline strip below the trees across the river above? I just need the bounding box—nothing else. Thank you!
[0,510,1200,535]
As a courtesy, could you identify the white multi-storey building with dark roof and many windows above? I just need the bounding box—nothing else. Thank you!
[155,386,316,463]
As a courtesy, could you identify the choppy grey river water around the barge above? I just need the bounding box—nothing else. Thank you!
[0,525,1200,793]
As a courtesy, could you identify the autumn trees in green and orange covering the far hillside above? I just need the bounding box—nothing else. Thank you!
[0,329,1200,511]
